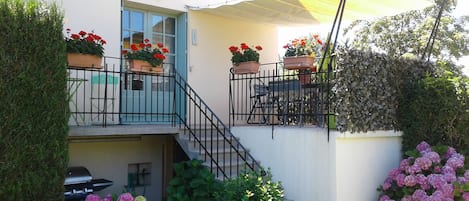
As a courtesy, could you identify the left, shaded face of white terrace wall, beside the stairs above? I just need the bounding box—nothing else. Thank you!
[232,126,335,201]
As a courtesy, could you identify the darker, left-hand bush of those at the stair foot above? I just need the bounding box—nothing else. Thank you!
[168,160,222,201]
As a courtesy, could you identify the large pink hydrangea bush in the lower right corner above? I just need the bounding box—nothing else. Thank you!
[378,141,469,201]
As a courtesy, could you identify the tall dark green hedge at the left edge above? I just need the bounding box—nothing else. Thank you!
[0,0,69,201]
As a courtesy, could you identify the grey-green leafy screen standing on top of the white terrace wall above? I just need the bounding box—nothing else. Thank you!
[333,48,432,132]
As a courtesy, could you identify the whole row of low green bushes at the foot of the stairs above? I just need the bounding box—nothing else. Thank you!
[168,160,284,201]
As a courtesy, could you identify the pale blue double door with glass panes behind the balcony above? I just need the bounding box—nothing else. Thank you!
[121,8,176,124]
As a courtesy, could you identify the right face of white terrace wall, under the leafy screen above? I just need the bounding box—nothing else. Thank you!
[334,131,402,201]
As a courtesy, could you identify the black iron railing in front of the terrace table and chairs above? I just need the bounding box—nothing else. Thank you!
[230,63,333,126]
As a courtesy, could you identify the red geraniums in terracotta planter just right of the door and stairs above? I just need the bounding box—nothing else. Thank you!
[228,43,262,74]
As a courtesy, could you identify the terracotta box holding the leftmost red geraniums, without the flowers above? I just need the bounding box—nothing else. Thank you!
[67,53,103,69]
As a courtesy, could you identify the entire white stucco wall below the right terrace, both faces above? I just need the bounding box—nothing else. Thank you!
[232,126,401,201]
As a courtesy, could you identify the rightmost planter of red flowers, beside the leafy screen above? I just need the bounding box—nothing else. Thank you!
[283,34,322,70]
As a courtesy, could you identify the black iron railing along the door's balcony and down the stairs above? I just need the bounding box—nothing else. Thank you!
[68,57,260,179]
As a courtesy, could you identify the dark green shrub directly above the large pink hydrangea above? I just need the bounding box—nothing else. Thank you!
[398,77,469,156]
